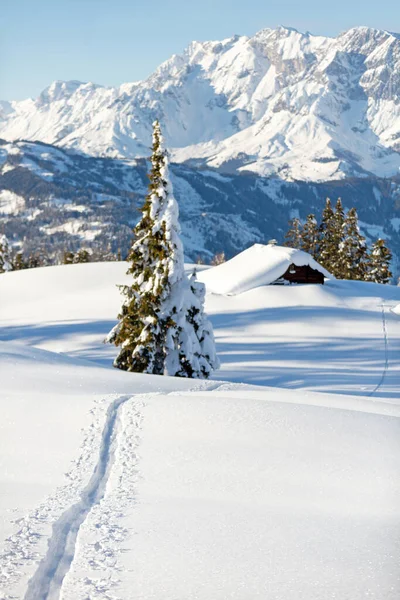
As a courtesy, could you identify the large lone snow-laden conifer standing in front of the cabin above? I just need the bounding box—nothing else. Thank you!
[107,121,219,377]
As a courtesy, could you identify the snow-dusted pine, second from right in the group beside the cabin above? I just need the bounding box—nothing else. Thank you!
[340,208,367,280]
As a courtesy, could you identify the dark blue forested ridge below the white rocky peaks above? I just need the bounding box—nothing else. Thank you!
[0,140,400,273]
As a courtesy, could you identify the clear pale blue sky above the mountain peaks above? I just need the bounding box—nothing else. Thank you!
[0,0,400,100]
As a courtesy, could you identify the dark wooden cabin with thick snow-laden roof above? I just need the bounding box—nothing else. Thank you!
[199,244,333,294]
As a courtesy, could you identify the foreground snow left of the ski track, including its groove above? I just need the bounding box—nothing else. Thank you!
[0,342,200,600]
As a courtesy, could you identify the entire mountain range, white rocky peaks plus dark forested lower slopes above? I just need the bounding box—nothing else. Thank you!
[0,27,400,270]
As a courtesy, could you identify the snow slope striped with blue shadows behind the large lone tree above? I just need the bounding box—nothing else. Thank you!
[0,263,400,398]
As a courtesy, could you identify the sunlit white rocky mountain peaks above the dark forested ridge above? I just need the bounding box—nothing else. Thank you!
[0,27,400,181]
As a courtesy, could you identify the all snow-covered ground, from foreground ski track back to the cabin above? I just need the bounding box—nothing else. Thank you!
[0,263,400,600]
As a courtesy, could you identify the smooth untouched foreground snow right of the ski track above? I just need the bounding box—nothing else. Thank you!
[110,390,399,600]
